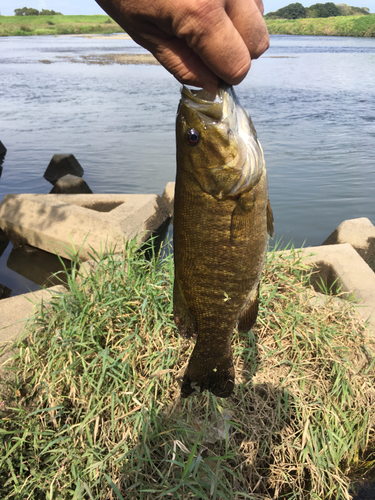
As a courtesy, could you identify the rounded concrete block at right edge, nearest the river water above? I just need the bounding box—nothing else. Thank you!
[322,217,375,271]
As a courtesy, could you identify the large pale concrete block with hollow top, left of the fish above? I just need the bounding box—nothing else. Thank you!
[0,194,169,261]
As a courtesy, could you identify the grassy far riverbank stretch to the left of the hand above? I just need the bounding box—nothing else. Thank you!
[0,15,123,36]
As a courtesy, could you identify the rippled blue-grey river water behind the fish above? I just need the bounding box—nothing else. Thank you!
[0,35,375,295]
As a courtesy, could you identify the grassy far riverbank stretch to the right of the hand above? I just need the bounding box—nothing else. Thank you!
[266,14,375,37]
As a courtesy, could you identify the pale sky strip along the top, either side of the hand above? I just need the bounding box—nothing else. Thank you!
[0,0,375,16]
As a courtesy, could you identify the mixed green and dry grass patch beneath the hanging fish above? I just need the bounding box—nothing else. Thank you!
[0,240,375,500]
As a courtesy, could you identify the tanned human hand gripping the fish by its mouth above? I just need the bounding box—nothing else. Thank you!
[96,0,269,94]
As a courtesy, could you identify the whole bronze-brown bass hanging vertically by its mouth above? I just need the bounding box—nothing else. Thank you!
[173,81,274,398]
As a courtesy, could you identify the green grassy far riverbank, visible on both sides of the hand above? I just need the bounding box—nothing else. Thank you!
[0,14,375,37]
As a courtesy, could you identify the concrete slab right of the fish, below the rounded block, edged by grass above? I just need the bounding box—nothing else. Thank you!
[303,243,375,340]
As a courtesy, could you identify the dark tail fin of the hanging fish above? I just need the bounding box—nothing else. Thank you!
[181,348,234,398]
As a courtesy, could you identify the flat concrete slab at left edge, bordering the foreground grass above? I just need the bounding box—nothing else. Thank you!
[0,285,66,375]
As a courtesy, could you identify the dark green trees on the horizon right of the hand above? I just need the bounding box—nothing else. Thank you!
[264,2,370,19]
